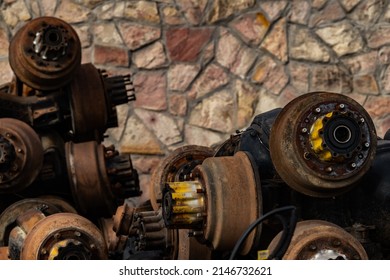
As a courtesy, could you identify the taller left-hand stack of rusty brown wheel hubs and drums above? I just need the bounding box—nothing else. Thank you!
[0,17,140,260]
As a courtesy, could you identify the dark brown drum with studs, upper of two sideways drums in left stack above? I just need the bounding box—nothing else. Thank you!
[69,63,135,141]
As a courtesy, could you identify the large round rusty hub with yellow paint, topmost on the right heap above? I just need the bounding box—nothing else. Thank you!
[270,92,376,197]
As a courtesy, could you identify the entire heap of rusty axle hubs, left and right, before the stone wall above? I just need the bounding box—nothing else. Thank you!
[0,17,390,260]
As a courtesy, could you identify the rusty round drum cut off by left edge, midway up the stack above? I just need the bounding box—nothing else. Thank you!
[0,118,43,192]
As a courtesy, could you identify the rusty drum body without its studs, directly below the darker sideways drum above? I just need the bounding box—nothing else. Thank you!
[65,141,118,217]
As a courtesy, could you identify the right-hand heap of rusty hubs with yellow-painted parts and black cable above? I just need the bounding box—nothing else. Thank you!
[114,92,390,260]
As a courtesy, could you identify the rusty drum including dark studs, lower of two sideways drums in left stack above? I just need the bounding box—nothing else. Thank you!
[65,141,140,217]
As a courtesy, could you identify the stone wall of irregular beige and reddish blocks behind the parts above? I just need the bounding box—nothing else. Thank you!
[0,0,390,197]
